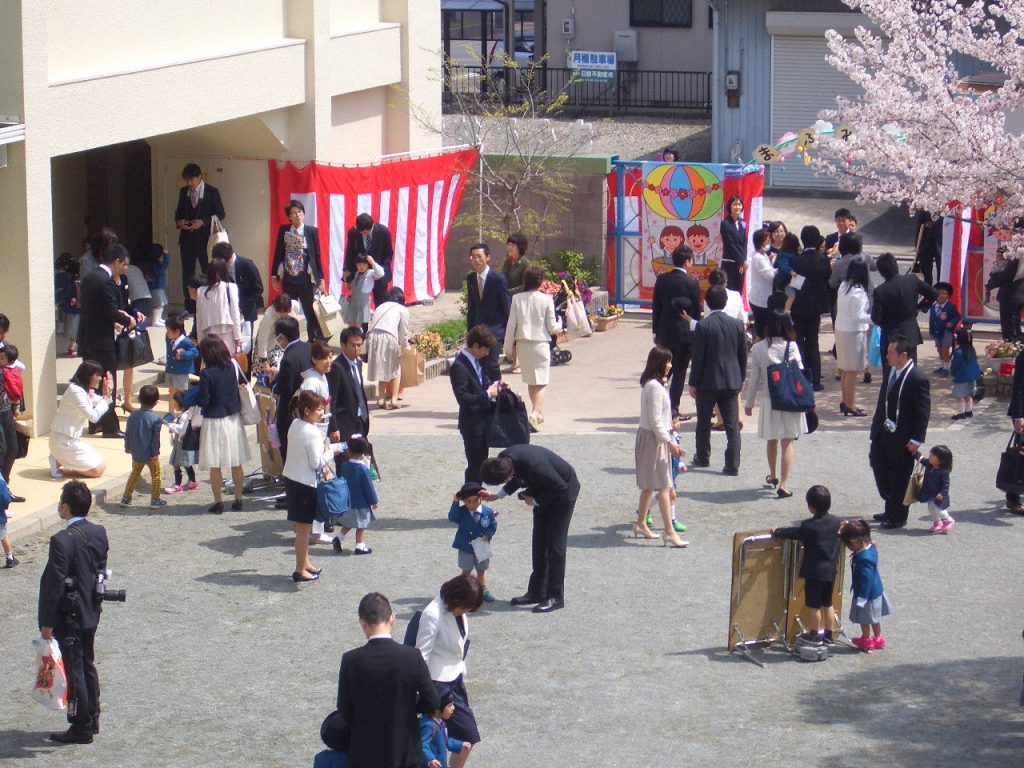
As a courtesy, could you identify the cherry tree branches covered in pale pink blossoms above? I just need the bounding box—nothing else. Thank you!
[815,0,1024,240]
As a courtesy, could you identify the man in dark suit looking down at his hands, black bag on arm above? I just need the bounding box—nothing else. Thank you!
[449,326,499,482]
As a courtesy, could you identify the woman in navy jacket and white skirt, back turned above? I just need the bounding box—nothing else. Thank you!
[196,334,250,515]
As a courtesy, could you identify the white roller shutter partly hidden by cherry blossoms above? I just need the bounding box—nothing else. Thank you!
[768,36,861,189]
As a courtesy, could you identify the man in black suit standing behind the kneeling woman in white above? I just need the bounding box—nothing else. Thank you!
[78,243,137,437]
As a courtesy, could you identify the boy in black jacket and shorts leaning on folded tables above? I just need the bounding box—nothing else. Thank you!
[771,485,842,644]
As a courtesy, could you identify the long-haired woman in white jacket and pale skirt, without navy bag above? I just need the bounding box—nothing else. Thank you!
[836,259,871,416]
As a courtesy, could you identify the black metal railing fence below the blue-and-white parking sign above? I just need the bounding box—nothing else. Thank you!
[443,66,711,115]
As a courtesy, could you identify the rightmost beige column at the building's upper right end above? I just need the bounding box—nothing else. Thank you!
[381,0,441,154]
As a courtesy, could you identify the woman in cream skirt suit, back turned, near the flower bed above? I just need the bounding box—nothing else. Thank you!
[505,266,561,429]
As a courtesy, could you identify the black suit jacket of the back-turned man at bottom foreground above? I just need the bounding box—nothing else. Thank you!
[338,638,440,768]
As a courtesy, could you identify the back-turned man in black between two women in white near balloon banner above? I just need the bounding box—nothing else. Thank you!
[790,226,831,392]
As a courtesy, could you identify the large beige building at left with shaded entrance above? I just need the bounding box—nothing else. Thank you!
[0,0,440,432]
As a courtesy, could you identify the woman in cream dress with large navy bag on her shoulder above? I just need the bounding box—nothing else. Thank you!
[744,311,805,499]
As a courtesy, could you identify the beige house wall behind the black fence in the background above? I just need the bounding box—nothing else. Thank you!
[547,0,712,72]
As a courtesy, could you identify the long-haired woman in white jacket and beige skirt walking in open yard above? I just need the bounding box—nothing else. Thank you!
[633,346,687,547]
